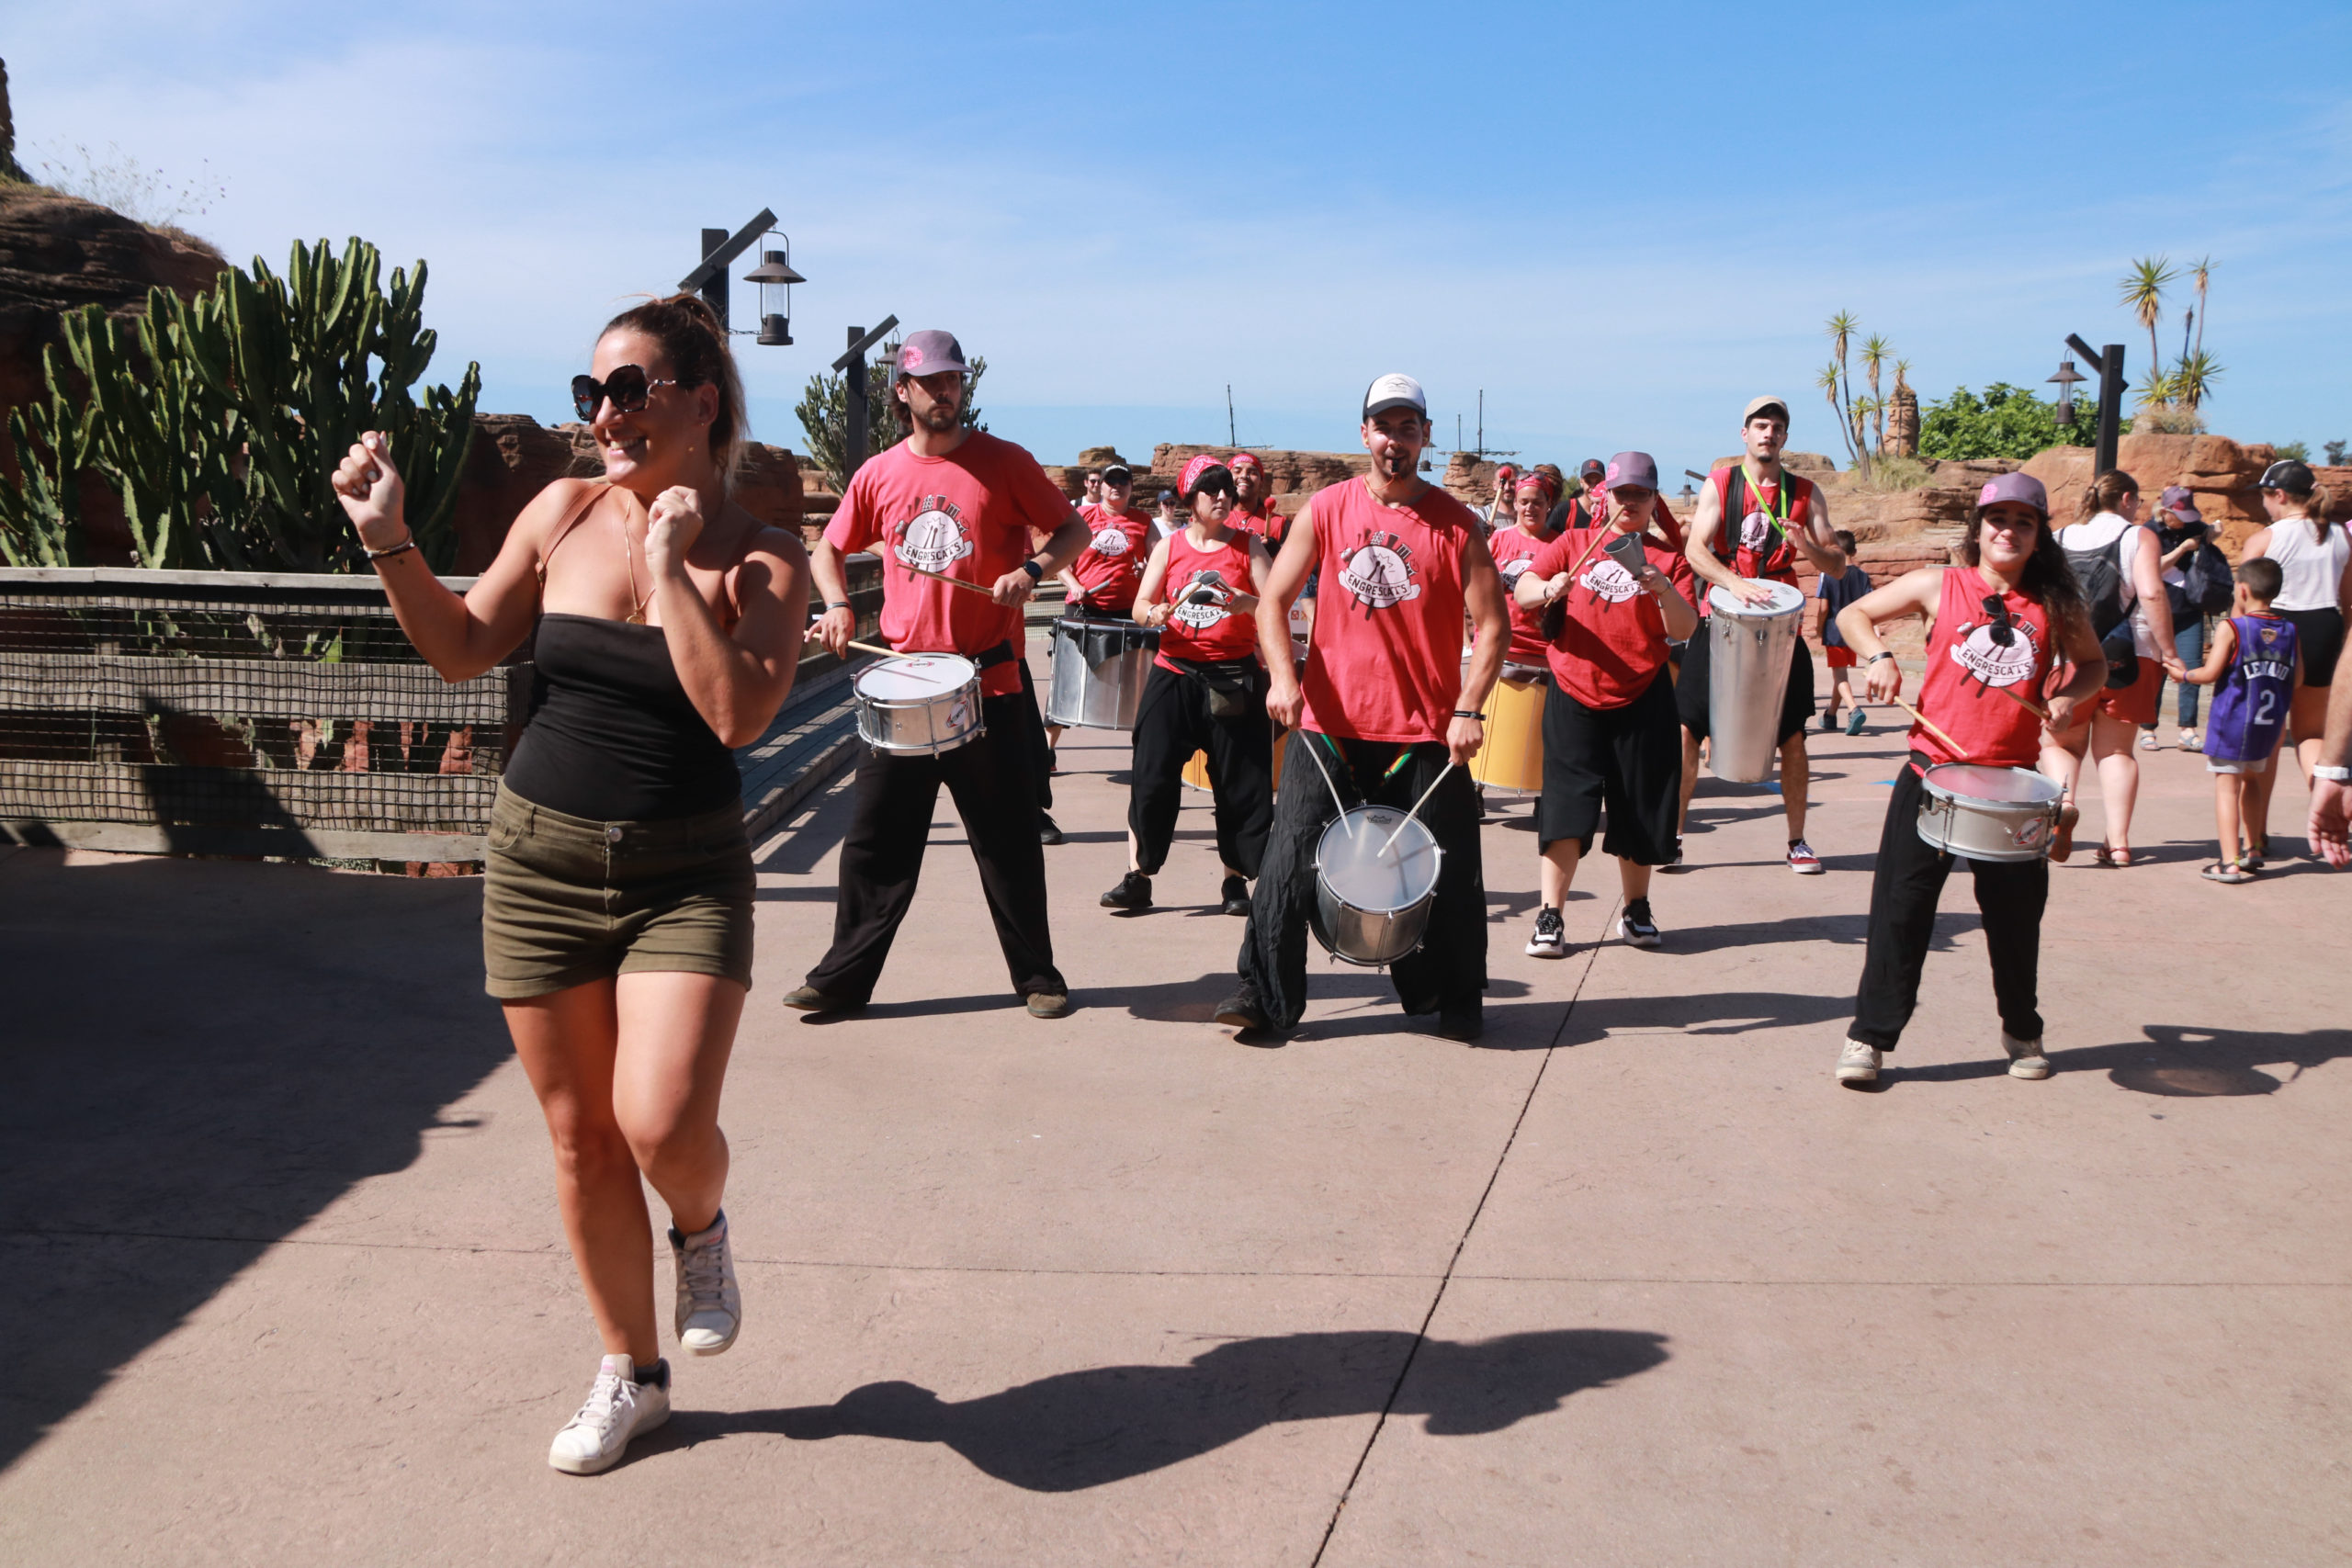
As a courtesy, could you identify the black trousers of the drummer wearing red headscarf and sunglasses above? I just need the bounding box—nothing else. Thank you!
[1126,663,1279,877]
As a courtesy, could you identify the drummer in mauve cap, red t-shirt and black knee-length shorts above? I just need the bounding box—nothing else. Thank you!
[1512,451,1698,959]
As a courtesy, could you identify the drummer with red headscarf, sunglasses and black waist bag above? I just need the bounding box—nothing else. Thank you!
[1103,451,1275,915]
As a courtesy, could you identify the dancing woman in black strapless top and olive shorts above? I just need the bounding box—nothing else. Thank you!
[334,294,809,1474]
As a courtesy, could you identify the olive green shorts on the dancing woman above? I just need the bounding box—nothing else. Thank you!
[482,783,752,1001]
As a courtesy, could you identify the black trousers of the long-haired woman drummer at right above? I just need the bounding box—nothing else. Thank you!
[1849,752,2051,1051]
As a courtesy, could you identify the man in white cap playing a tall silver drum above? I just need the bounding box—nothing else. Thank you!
[1675,398,1847,877]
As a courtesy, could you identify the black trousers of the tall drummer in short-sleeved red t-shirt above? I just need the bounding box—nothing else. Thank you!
[809,691,1068,1004]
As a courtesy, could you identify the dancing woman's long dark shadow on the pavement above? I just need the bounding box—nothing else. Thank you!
[653,1328,1668,1493]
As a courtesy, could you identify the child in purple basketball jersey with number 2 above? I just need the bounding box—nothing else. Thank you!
[2189,555,2302,882]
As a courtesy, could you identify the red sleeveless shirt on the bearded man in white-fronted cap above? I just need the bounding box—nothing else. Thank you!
[1291,479,1487,743]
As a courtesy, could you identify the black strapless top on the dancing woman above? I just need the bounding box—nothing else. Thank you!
[505,614,743,823]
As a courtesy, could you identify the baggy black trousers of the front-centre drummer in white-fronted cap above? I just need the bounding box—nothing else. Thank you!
[1238,731,1487,1030]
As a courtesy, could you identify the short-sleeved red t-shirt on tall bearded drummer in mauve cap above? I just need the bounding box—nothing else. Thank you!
[826,430,1070,696]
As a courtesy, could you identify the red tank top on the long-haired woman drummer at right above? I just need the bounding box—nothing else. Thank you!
[1910,567,2053,769]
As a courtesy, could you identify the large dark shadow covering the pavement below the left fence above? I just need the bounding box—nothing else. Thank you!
[0,851,508,1470]
